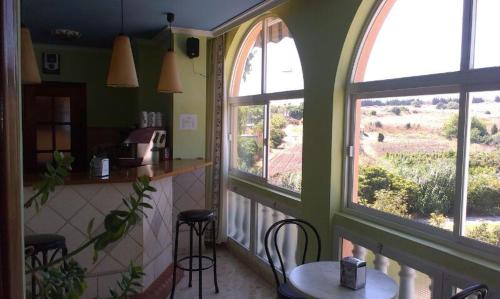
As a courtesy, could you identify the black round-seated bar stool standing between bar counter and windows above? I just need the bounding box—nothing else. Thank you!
[170,210,219,299]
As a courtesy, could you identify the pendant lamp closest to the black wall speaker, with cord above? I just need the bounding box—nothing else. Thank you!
[157,13,182,93]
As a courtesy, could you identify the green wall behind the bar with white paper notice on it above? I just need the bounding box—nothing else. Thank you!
[35,34,207,158]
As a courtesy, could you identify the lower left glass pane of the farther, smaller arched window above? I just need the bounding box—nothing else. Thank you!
[232,105,265,176]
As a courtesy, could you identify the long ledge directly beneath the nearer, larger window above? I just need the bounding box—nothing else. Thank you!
[333,209,500,286]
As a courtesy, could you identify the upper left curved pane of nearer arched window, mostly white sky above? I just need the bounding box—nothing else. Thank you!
[355,0,463,82]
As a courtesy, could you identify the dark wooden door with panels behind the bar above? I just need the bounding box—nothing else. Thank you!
[23,82,87,172]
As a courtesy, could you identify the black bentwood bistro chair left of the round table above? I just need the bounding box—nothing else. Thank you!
[264,219,321,299]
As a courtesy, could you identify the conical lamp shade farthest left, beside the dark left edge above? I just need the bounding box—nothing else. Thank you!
[21,26,42,84]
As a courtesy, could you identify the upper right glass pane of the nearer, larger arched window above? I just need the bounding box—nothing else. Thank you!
[474,0,500,68]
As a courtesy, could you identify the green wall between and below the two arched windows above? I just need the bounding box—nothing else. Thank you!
[225,0,500,285]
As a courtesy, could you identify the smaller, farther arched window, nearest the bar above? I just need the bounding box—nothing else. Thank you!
[229,17,304,194]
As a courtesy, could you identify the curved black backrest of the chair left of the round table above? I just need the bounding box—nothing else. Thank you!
[264,219,321,287]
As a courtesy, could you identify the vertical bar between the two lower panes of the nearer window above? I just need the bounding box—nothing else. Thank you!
[453,90,470,238]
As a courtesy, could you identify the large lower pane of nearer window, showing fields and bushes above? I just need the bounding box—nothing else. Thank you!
[353,94,459,230]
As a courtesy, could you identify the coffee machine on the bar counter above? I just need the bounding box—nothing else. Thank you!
[119,128,167,167]
